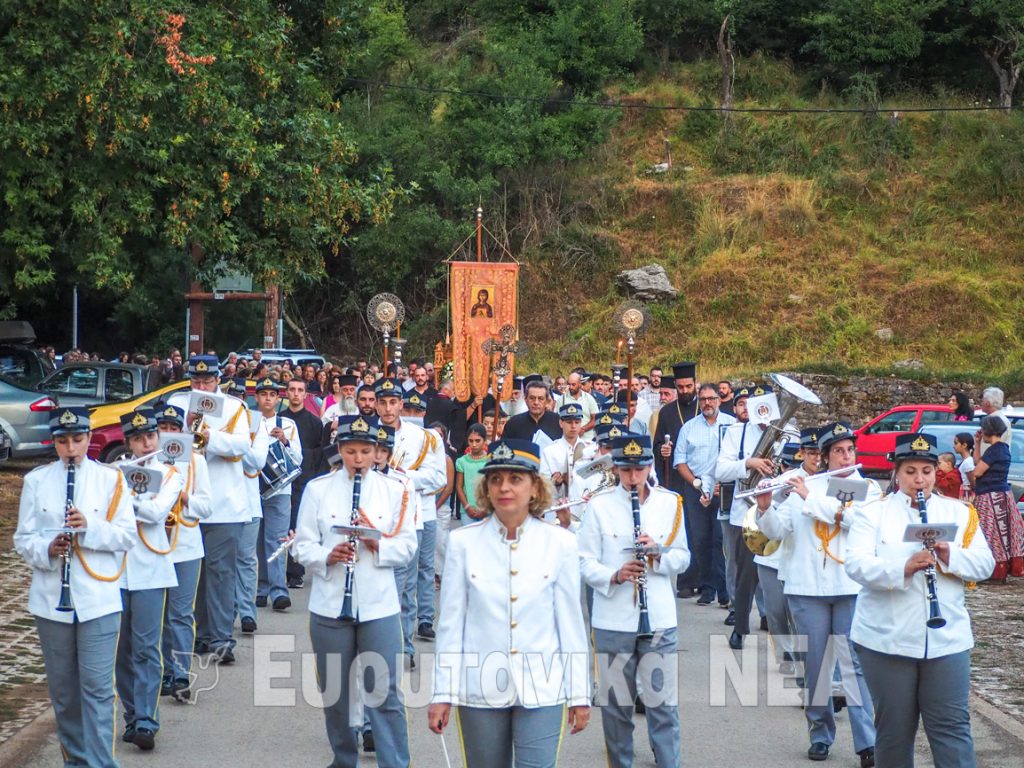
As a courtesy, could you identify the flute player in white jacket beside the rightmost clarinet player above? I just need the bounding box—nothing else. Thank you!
[756,422,882,768]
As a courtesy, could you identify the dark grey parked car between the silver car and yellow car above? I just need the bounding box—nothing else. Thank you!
[36,362,161,408]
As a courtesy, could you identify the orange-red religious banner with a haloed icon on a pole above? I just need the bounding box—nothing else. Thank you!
[450,261,519,400]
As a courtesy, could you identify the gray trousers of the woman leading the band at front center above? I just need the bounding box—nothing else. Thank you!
[456,705,565,768]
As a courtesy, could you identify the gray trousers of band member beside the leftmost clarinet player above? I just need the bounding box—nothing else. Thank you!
[117,589,167,731]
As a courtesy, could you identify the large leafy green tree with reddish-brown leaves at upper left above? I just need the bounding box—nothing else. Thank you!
[0,0,397,319]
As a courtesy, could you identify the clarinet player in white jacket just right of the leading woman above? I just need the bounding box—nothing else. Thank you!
[579,434,690,768]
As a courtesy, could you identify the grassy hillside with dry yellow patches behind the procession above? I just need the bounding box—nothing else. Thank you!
[521,58,1024,385]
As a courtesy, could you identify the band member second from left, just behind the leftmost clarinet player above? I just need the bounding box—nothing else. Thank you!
[117,408,184,751]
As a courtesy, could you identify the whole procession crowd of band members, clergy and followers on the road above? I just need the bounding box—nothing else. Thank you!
[15,352,1024,767]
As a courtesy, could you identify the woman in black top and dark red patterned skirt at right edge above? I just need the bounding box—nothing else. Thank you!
[974,417,1024,582]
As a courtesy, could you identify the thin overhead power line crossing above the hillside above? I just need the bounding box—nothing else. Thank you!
[345,78,1021,115]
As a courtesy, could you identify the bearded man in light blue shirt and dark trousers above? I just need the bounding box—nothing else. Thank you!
[672,384,736,608]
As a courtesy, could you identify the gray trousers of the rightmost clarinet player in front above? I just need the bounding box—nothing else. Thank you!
[857,645,975,768]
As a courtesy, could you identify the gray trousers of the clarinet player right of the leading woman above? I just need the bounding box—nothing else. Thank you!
[594,629,680,768]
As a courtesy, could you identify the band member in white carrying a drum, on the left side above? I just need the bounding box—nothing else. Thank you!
[256,377,303,610]
